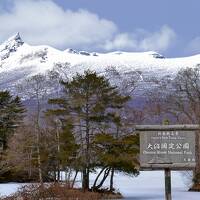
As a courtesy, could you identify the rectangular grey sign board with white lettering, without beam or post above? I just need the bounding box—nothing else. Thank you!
[140,126,196,169]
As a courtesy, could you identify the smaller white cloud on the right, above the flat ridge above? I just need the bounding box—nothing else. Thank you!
[104,25,176,51]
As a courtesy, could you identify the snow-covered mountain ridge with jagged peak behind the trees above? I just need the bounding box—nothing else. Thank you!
[0,33,200,97]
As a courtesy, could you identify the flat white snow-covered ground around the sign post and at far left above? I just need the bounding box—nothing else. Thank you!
[0,171,200,200]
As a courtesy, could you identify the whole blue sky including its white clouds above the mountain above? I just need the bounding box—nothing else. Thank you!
[0,0,200,57]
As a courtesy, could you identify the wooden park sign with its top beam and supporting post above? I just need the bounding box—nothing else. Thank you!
[135,125,200,200]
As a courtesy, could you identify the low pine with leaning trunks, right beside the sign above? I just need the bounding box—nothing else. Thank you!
[92,133,139,192]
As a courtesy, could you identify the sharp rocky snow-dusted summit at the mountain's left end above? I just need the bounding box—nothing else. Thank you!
[0,33,24,60]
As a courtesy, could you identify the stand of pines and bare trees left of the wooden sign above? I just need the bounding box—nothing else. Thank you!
[0,71,139,191]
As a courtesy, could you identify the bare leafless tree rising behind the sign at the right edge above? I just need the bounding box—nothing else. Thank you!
[147,65,200,189]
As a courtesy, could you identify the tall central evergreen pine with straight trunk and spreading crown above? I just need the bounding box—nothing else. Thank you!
[49,71,129,190]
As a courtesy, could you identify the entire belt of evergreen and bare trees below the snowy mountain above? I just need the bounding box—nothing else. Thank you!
[0,65,200,198]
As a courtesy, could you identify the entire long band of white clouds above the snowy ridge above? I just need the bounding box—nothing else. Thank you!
[0,0,176,51]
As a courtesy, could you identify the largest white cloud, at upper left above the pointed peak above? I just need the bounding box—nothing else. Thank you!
[0,0,117,48]
